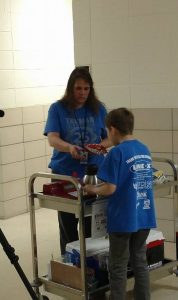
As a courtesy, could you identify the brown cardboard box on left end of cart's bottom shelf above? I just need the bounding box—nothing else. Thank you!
[51,260,82,290]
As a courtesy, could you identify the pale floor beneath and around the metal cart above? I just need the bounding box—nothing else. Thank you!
[0,209,178,300]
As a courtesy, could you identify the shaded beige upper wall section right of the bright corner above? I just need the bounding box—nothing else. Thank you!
[73,0,178,108]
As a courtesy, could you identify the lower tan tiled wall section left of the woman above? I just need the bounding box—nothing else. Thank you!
[0,105,51,218]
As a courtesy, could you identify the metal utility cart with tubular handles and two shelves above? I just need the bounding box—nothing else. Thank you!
[28,158,178,300]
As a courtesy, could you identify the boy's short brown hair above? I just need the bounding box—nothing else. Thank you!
[105,107,134,135]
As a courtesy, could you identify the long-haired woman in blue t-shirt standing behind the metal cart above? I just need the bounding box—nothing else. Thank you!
[44,67,110,255]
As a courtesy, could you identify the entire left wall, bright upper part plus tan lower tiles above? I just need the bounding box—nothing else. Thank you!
[0,0,74,218]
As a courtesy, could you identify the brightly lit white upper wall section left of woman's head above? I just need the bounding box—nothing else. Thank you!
[0,0,74,109]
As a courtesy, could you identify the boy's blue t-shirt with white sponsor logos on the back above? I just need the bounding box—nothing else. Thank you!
[97,140,156,233]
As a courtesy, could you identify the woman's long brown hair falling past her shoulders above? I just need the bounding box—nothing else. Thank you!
[60,67,101,114]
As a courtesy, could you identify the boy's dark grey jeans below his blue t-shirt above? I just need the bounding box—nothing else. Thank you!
[109,230,150,300]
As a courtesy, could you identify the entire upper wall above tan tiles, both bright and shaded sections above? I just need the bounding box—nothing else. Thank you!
[0,0,178,109]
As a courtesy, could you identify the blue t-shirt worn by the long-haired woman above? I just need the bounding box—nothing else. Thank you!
[44,101,107,178]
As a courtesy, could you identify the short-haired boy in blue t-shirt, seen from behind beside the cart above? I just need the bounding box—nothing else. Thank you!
[84,108,156,300]
